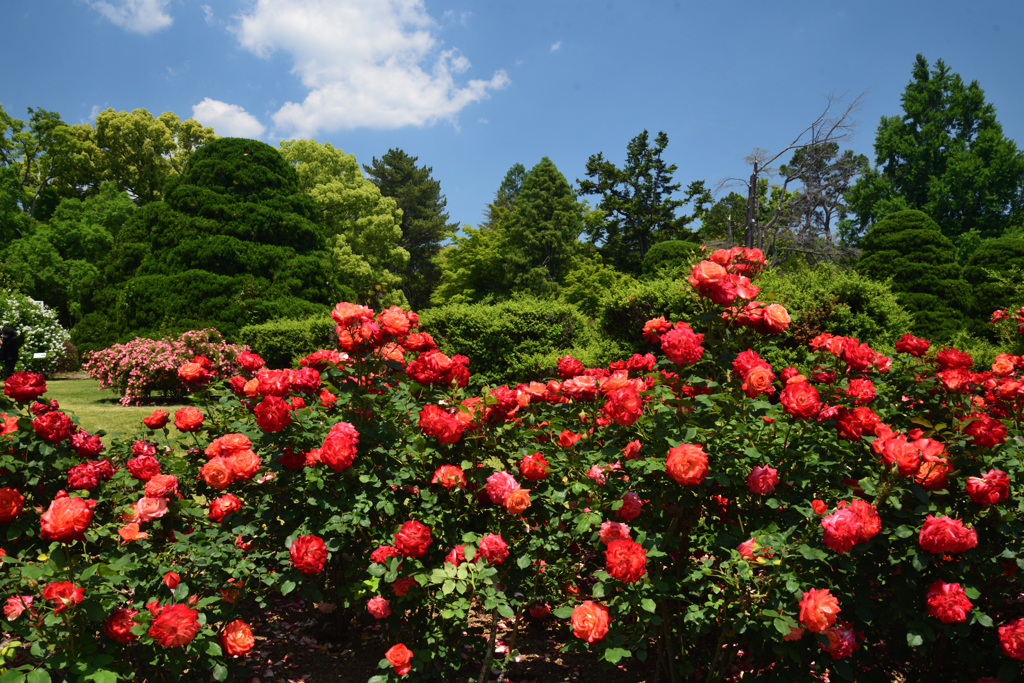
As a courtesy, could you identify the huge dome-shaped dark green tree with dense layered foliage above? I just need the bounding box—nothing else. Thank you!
[76,138,339,349]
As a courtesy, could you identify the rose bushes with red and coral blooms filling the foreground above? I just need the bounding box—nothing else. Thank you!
[0,249,1024,683]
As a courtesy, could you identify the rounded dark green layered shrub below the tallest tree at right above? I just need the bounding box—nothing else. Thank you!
[856,210,972,340]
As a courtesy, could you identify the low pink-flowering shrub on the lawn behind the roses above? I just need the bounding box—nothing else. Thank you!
[82,329,249,405]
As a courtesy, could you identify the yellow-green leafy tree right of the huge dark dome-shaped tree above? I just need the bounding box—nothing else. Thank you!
[280,140,409,303]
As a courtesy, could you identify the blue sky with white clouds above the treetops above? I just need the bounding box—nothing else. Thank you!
[0,0,1024,229]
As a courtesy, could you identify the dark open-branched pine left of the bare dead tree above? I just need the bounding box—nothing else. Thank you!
[577,130,706,273]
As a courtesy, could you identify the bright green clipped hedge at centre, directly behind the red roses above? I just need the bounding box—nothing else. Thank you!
[420,297,597,384]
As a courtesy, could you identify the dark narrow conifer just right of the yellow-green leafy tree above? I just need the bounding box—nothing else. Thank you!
[362,148,459,308]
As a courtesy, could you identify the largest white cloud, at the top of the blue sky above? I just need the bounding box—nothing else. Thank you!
[229,0,509,136]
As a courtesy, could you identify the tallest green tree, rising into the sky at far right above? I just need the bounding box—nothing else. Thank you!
[849,54,1024,238]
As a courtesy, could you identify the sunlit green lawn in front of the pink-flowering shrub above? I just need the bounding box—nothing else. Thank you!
[43,379,185,444]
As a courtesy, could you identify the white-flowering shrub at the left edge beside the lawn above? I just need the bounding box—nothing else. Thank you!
[0,290,71,374]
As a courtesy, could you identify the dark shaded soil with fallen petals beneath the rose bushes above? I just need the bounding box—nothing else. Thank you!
[236,599,653,683]
